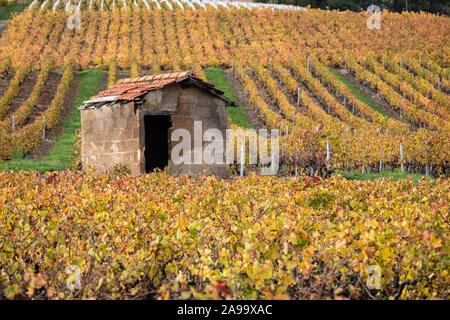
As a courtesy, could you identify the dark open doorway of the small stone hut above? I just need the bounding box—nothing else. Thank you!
[144,115,171,173]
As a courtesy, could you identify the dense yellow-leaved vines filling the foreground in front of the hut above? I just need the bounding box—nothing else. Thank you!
[0,171,450,299]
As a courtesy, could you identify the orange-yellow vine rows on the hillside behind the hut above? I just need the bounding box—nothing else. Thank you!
[0,1,450,176]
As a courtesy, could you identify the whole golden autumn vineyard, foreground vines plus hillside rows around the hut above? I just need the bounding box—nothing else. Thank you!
[0,0,450,299]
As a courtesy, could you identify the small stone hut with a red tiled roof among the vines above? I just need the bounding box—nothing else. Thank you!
[80,71,235,176]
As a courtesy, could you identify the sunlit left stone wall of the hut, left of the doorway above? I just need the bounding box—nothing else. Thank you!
[81,103,143,175]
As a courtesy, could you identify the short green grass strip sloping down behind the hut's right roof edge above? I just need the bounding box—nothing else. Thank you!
[205,68,253,129]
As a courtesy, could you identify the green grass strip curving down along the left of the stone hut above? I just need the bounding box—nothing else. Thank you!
[0,70,103,172]
